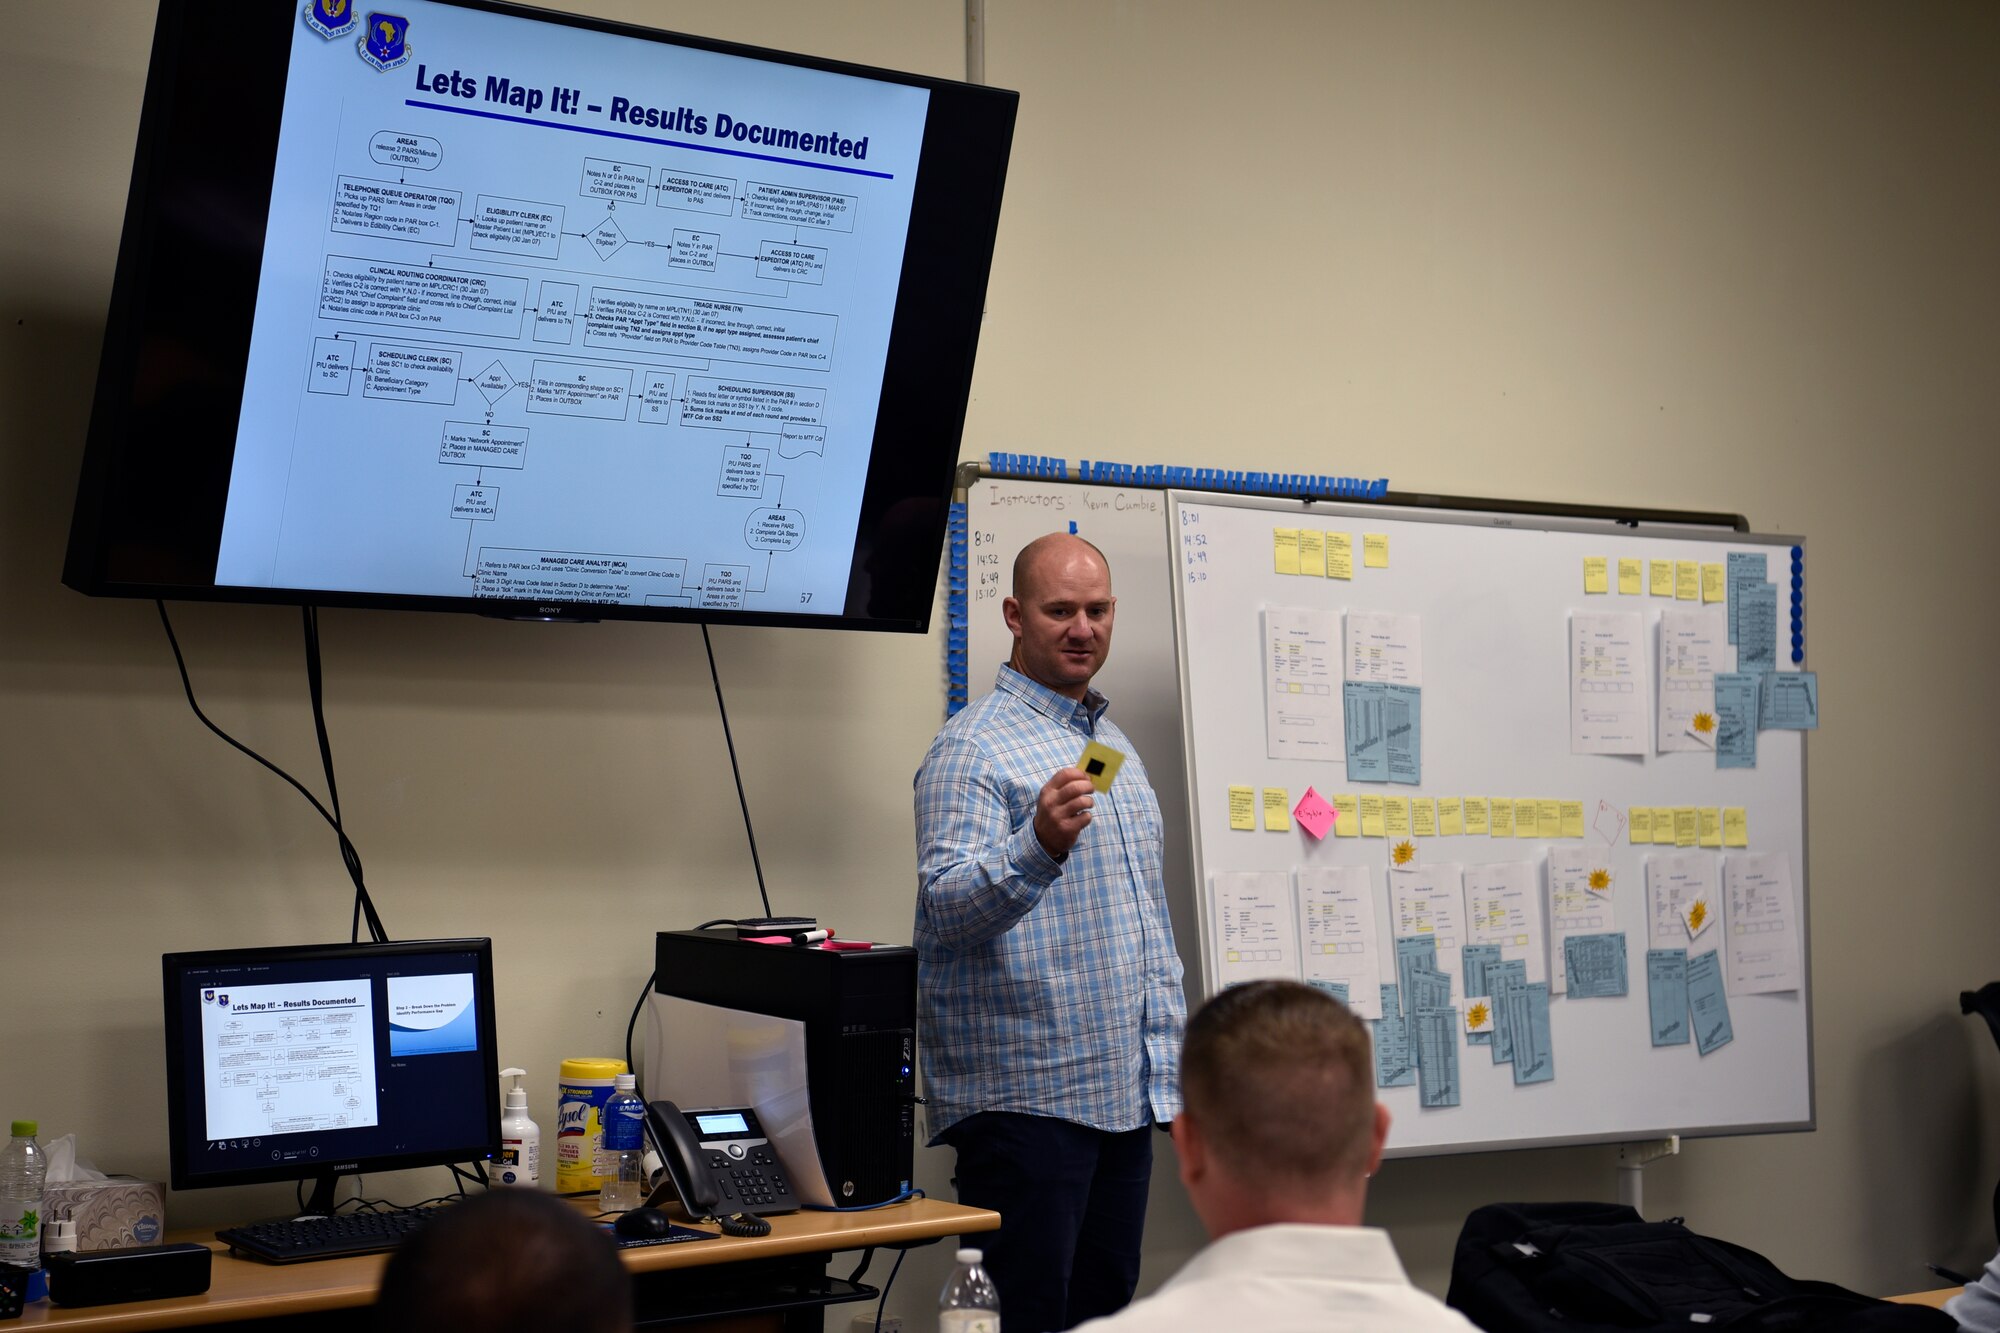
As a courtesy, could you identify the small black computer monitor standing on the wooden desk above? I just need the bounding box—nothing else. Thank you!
[160,939,500,1213]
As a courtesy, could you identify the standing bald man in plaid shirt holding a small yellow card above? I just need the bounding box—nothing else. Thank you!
[916,534,1186,1333]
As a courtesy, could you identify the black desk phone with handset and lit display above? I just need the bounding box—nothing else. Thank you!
[646,1101,798,1235]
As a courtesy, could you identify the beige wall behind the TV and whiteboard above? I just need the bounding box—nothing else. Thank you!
[0,0,2000,1304]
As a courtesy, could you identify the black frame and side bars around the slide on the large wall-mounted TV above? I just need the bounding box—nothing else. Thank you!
[62,0,1020,632]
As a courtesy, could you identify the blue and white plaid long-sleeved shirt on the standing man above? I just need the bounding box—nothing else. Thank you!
[916,667,1188,1143]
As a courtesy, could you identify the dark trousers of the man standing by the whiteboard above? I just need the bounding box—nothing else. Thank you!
[940,1111,1152,1333]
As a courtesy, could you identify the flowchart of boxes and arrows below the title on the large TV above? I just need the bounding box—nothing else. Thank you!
[278,128,900,610]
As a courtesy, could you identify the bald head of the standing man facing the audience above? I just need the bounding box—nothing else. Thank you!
[1000,532,1118,701]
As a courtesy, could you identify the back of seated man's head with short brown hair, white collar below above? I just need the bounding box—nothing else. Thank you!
[1174,981,1388,1235]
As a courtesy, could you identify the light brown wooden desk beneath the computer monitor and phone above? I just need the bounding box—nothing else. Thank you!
[10,1199,1000,1333]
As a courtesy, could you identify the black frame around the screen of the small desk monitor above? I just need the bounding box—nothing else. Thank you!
[160,939,500,1193]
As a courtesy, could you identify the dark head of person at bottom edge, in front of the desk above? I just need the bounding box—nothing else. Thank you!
[376,1189,632,1333]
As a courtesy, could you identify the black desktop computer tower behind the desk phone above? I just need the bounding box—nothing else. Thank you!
[644,931,916,1207]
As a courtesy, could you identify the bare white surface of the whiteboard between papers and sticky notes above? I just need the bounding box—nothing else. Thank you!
[1168,490,1814,1153]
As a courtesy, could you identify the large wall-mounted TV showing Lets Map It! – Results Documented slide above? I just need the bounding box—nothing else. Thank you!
[64,0,1016,630]
